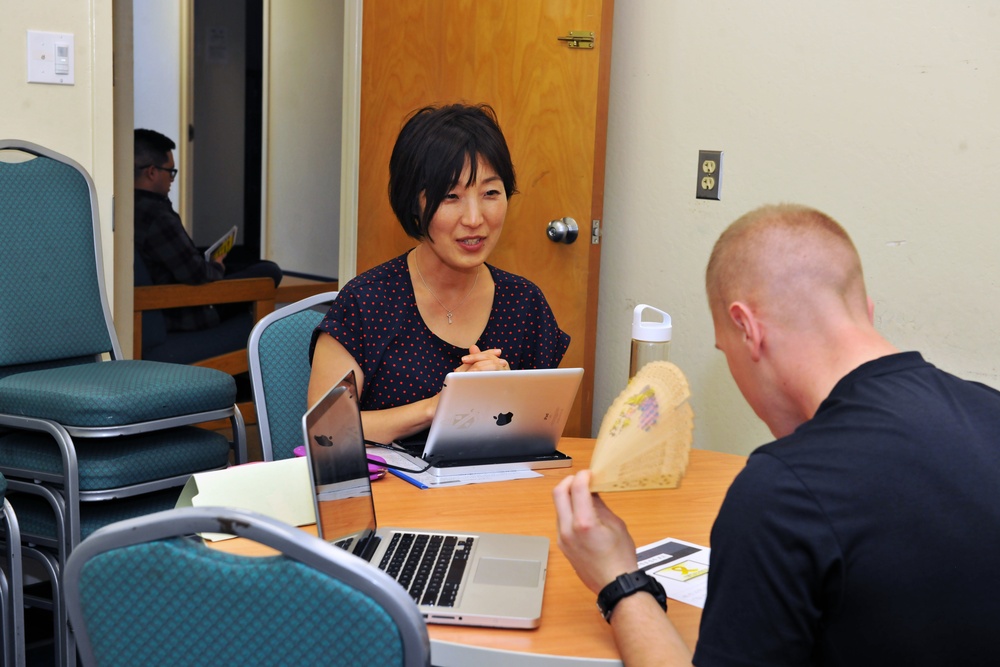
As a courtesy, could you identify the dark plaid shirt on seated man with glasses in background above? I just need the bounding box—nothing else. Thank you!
[135,190,225,331]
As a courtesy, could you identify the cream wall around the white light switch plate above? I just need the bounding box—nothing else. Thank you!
[0,0,114,298]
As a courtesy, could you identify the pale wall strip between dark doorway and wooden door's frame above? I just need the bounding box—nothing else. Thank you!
[264,0,344,277]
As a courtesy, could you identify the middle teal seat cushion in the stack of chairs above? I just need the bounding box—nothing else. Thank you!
[0,426,230,491]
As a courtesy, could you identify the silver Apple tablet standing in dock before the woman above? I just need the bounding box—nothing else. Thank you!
[403,368,583,476]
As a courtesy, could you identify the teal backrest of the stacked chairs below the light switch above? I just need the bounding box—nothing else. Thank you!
[0,139,121,367]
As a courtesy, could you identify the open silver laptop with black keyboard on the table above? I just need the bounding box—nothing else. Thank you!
[302,372,549,628]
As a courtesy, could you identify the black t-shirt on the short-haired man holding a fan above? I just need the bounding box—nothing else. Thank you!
[695,352,1000,667]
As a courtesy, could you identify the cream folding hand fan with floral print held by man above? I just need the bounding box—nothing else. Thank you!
[590,361,694,491]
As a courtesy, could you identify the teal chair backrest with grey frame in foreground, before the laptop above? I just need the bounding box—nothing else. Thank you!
[63,507,430,667]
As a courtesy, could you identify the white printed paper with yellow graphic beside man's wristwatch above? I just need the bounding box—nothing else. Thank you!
[635,537,712,609]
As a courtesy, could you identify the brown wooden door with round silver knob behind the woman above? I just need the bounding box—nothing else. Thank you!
[357,0,613,436]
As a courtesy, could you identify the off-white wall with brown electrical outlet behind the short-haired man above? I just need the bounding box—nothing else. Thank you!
[594,0,1000,453]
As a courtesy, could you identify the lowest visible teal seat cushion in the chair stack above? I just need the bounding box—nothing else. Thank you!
[9,487,181,542]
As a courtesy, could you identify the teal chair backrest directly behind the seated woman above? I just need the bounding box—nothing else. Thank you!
[247,292,337,461]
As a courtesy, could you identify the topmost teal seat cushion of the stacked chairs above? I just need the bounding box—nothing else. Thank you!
[0,360,236,427]
